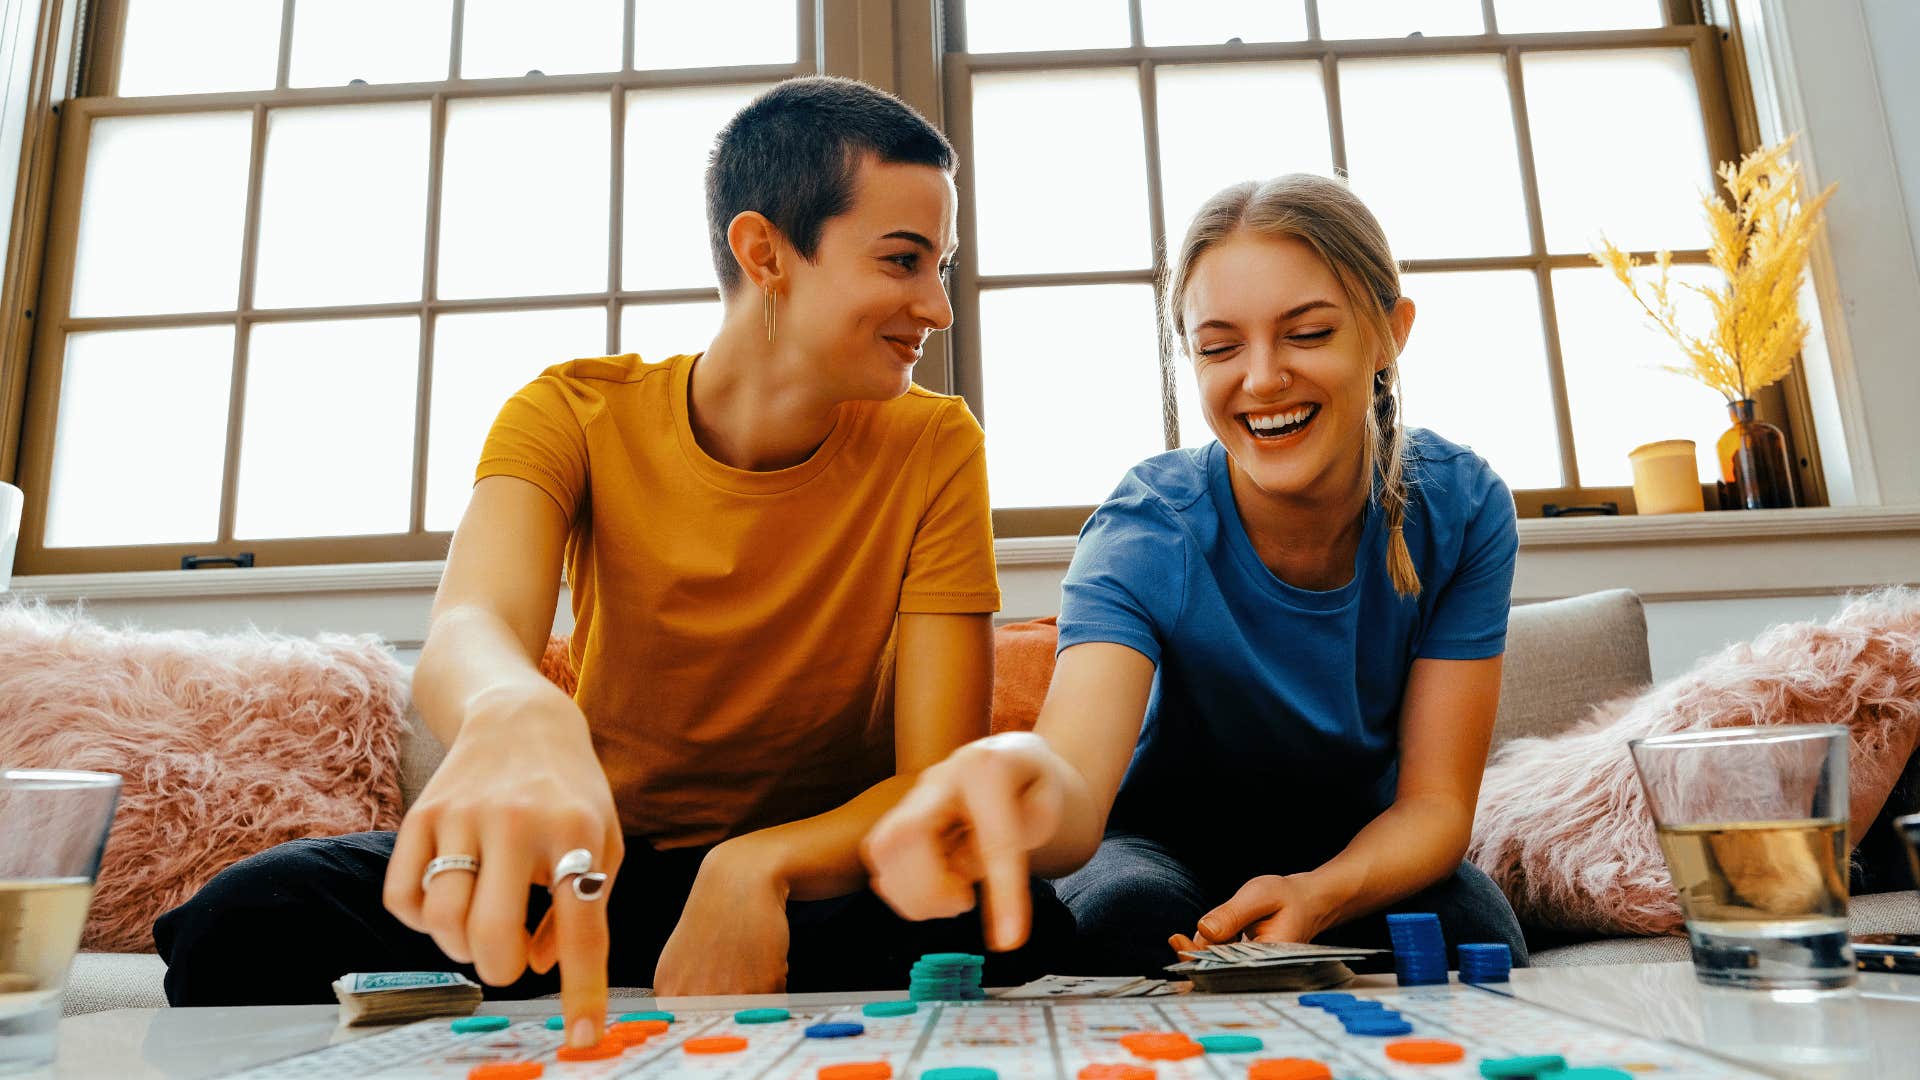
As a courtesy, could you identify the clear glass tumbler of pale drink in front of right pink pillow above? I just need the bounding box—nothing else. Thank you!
[1628,724,1855,990]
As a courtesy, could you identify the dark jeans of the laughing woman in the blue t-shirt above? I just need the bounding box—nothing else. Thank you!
[1054,832,1526,976]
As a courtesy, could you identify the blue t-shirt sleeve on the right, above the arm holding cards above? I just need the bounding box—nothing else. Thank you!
[1419,465,1521,659]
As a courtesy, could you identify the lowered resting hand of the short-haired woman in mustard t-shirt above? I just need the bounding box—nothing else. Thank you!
[641,844,791,997]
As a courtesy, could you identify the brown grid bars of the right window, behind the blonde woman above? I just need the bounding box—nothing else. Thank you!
[945,0,1816,536]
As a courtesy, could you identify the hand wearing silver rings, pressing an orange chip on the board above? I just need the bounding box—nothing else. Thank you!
[382,684,624,1045]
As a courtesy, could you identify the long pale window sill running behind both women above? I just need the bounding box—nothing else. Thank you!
[13,507,1920,613]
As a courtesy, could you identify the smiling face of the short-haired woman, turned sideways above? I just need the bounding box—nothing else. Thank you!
[771,154,958,400]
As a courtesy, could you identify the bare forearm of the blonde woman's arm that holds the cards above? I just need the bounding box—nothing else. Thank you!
[1309,796,1473,930]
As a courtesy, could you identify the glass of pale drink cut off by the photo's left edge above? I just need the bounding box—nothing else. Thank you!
[0,769,119,1072]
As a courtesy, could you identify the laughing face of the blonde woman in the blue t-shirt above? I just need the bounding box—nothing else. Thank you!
[1185,229,1411,505]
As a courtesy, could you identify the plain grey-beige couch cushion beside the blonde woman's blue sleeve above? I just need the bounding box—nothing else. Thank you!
[1494,588,1653,749]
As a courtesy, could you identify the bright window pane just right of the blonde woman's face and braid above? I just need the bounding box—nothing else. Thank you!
[1400,271,1567,488]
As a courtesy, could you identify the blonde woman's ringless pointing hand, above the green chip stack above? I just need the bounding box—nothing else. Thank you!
[860,732,1066,951]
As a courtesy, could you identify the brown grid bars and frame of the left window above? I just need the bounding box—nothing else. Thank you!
[19,0,822,573]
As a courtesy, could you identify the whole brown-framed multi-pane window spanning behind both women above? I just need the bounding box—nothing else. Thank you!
[0,0,1820,575]
